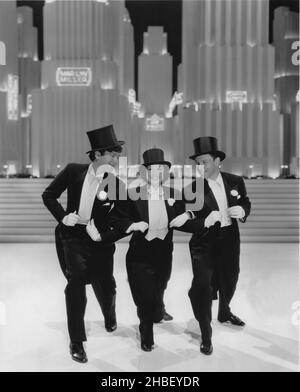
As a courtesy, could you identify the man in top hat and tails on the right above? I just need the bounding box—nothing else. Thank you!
[173,137,251,355]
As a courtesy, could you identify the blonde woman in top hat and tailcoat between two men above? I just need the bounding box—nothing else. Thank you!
[110,148,191,351]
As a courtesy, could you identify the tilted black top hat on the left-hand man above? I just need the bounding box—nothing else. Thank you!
[87,125,125,154]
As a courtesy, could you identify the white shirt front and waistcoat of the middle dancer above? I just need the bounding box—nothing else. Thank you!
[145,187,169,241]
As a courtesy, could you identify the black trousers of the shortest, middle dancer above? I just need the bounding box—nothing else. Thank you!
[126,237,173,326]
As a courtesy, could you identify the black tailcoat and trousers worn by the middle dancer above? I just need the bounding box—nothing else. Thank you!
[110,187,185,330]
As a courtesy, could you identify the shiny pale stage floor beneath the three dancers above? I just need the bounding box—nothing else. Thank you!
[0,244,300,372]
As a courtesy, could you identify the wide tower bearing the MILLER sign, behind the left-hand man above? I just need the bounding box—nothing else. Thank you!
[32,0,137,175]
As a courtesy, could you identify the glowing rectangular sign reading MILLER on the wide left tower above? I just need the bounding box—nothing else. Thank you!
[56,67,92,86]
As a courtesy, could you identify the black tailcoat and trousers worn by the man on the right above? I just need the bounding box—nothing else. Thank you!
[176,173,251,341]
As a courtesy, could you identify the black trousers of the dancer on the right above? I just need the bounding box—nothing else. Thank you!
[189,225,240,343]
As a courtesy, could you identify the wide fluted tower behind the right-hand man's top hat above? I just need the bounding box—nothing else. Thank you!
[178,0,282,177]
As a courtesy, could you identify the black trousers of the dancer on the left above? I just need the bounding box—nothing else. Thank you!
[56,225,116,342]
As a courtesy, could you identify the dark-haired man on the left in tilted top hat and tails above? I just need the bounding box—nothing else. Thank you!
[42,125,124,363]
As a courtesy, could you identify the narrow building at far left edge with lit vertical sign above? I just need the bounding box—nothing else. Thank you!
[0,1,40,174]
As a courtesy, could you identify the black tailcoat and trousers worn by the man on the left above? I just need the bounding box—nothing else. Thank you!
[42,163,124,342]
